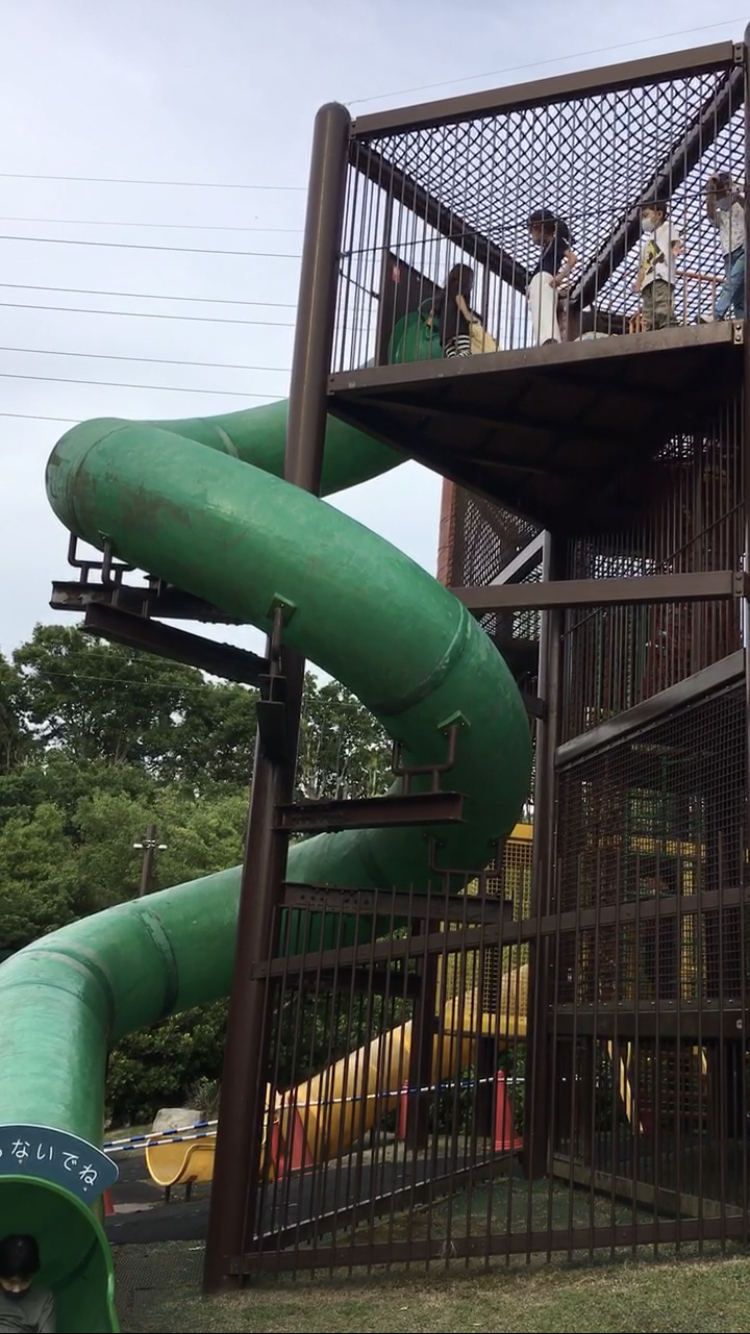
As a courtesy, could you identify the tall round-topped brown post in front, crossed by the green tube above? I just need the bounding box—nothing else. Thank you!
[203,103,351,1293]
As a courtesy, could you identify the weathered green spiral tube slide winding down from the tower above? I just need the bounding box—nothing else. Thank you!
[0,320,531,1334]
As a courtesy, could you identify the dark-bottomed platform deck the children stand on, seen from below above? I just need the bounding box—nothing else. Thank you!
[328,323,742,531]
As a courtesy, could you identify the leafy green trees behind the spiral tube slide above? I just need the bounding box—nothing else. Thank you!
[0,626,391,1125]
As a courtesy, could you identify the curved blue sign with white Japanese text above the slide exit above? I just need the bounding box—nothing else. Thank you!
[0,1126,119,1205]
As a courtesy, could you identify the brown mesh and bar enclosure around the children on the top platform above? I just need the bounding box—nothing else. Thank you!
[334,52,743,371]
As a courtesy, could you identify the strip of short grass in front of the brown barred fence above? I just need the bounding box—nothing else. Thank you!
[115,1245,750,1334]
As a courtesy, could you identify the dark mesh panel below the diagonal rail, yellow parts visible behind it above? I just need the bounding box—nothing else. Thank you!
[556,687,747,1006]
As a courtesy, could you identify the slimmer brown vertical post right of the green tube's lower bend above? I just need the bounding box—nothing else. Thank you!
[522,534,565,1179]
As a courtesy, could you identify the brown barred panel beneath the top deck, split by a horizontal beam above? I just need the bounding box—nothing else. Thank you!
[563,400,745,739]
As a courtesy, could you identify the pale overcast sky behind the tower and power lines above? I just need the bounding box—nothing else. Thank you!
[0,0,745,667]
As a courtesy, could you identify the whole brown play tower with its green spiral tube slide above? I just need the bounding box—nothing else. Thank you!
[0,31,750,1331]
